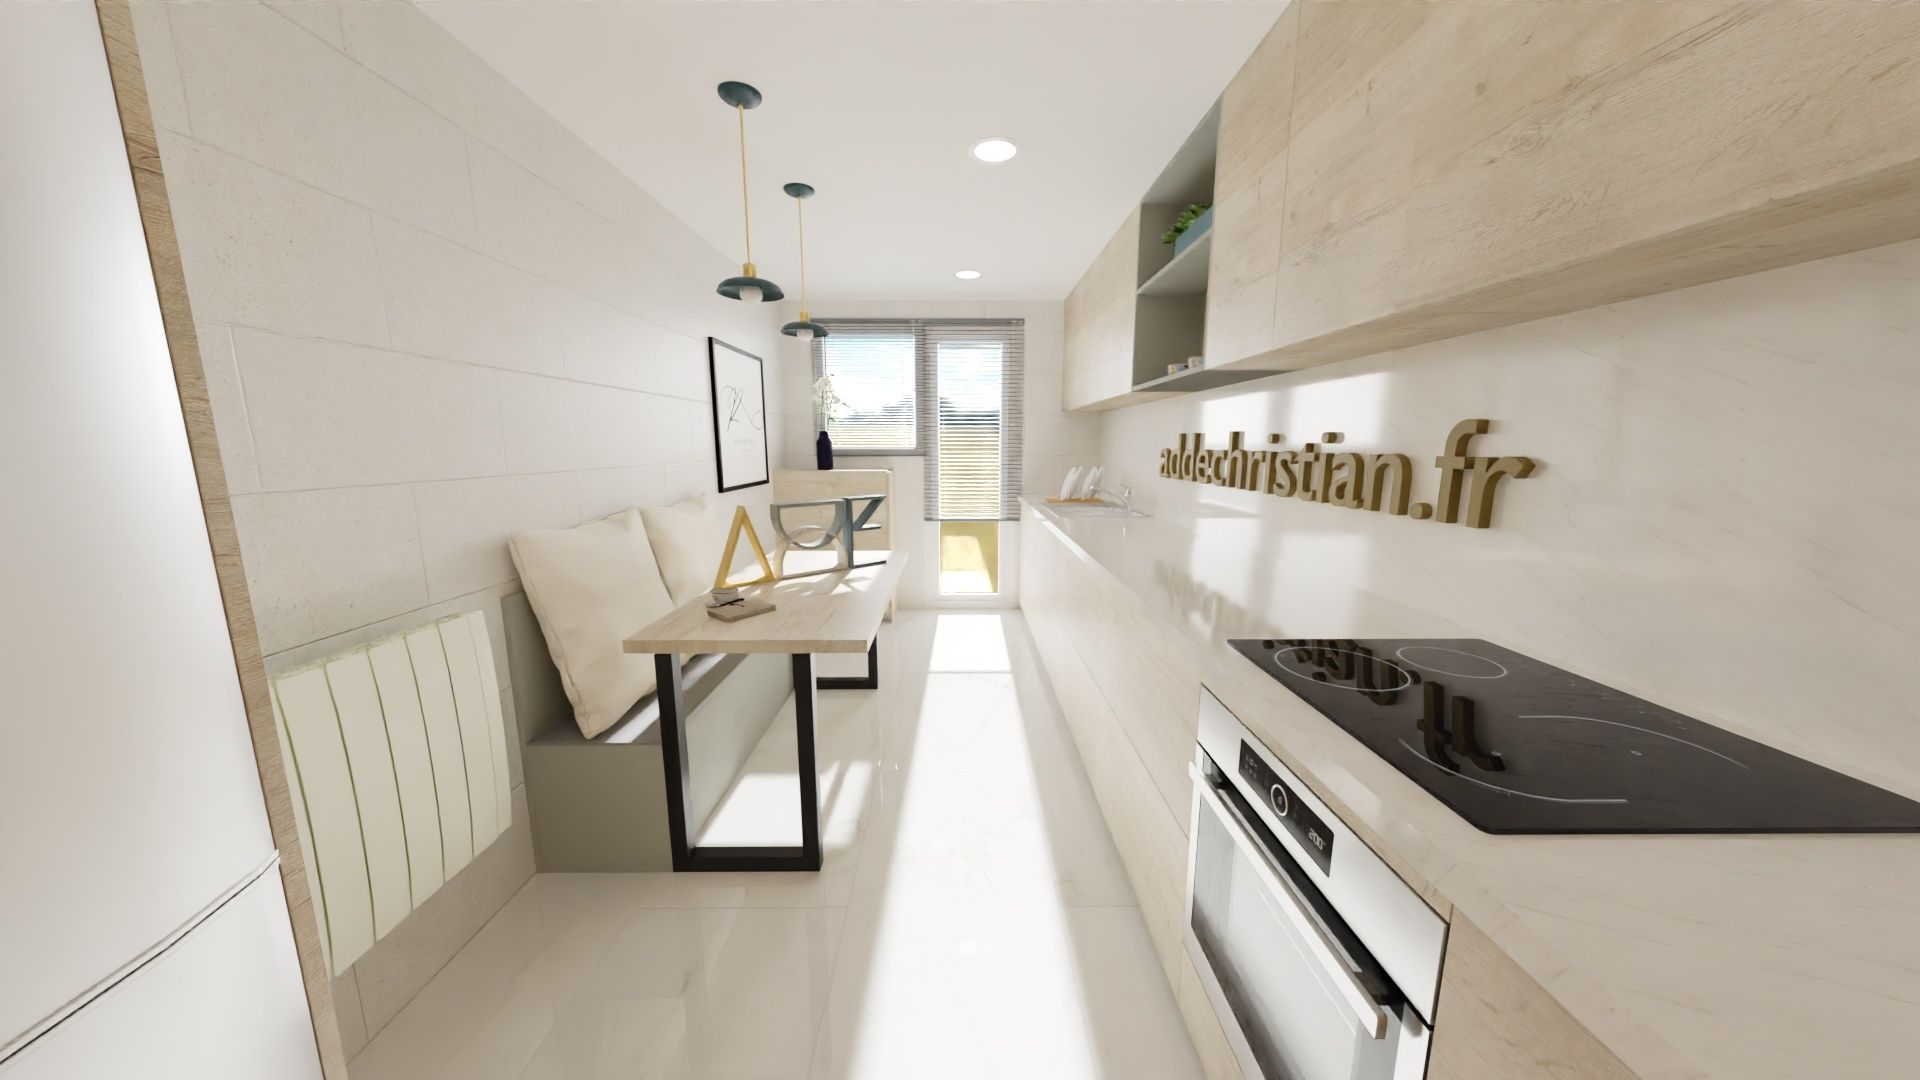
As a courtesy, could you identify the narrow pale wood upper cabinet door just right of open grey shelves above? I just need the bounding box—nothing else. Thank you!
[1206,4,1300,365]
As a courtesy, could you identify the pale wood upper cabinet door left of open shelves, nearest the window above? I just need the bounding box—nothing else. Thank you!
[1060,208,1140,409]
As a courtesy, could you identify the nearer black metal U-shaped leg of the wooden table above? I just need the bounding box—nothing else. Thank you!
[653,653,822,872]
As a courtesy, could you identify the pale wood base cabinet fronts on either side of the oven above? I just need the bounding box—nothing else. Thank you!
[1020,509,1636,1080]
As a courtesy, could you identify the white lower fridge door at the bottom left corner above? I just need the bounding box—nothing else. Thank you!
[0,865,321,1080]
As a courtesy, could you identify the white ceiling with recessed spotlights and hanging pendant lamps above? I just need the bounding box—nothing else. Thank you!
[420,0,1284,307]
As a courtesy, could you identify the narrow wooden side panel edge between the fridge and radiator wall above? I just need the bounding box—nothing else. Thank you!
[94,0,348,1080]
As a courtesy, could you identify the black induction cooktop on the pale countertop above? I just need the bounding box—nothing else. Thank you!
[1229,638,1920,832]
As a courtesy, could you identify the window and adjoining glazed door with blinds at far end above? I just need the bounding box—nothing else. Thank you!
[814,319,1025,596]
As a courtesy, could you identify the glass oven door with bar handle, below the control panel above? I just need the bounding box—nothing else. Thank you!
[1188,757,1400,1080]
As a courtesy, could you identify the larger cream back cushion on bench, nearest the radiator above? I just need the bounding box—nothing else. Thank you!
[509,509,674,738]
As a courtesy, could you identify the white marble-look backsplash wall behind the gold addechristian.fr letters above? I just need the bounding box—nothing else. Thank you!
[1102,242,1920,796]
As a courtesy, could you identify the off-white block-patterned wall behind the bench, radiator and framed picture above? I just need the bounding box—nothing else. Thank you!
[136,0,783,1053]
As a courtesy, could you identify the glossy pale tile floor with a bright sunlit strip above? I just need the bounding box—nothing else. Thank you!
[351,611,1200,1080]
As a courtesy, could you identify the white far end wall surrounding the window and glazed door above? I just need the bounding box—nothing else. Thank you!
[781,300,1100,607]
